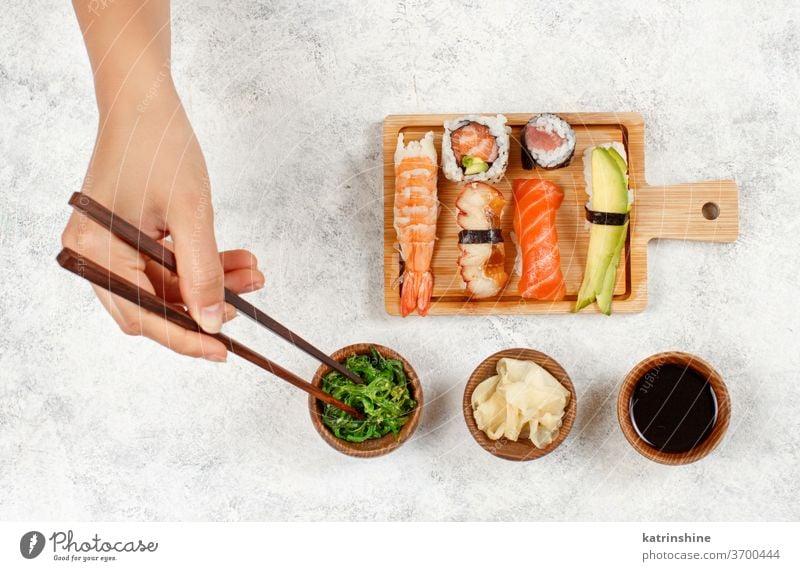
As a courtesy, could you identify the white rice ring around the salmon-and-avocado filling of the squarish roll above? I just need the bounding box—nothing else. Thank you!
[442,115,511,183]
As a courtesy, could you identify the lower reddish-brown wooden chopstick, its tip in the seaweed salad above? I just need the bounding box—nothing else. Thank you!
[56,248,364,419]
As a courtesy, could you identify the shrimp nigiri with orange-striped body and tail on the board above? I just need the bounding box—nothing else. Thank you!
[394,131,439,317]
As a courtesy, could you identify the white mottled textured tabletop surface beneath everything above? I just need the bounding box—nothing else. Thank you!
[0,0,800,520]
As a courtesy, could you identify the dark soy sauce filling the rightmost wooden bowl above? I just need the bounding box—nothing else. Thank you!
[630,365,717,453]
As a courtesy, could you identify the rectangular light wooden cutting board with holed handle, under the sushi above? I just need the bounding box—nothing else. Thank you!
[383,113,739,315]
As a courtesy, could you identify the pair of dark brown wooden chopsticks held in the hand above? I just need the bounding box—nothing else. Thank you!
[57,192,363,418]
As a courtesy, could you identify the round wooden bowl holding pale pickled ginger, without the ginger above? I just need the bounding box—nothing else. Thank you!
[462,349,577,461]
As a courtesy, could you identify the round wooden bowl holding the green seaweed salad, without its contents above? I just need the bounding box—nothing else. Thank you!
[308,343,422,458]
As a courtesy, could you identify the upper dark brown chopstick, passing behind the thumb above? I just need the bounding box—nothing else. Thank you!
[69,192,364,384]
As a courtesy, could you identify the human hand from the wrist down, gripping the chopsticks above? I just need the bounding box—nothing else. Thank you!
[62,85,264,361]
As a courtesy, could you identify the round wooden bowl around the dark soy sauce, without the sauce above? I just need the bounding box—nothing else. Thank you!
[617,351,731,466]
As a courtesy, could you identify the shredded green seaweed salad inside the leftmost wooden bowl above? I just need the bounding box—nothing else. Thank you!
[322,348,417,442]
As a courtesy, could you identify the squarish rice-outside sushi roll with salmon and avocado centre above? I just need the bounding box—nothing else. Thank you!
[442,115,511,182]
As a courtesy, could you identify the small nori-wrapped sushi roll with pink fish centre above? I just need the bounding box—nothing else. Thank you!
[521,113,575,170]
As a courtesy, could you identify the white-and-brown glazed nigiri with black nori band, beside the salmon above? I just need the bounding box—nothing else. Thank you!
[456,182,508,299]
